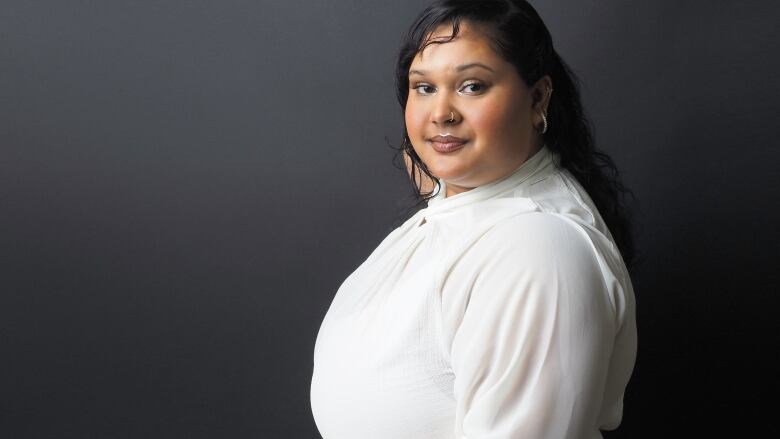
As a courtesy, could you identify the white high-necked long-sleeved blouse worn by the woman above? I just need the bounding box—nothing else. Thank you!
[311,146,637,439]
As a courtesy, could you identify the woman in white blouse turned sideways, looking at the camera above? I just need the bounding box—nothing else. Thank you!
[311,0,636,439]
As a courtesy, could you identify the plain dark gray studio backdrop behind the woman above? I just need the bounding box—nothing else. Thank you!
[0,0,780,438]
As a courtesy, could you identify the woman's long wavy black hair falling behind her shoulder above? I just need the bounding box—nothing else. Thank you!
[396,0,634,268]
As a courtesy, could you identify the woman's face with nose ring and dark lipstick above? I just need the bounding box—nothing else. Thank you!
[405,22,551,196]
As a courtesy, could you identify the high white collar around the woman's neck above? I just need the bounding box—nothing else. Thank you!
[420,145,557,216]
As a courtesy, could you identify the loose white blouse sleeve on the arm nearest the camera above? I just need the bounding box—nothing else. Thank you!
[442,213,616,439]
